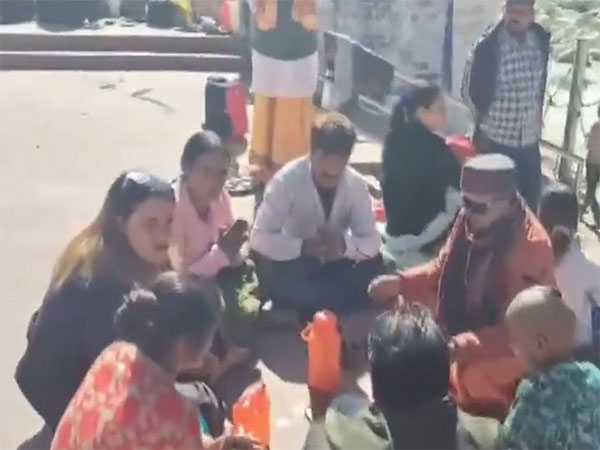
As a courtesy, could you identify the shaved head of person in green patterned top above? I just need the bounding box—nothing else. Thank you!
[506,286,576,372]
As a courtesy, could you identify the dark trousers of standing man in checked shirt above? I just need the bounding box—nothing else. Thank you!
[476,132,542,213]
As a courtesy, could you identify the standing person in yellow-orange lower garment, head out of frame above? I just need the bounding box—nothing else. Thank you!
[249,0,319,206]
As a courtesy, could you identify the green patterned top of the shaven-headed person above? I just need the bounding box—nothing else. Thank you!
[502,362,600,449]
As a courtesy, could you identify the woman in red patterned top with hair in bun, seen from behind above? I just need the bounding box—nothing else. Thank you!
[51,272,258,450]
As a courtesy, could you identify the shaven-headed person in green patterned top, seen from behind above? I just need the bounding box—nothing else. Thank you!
[502,286,600,449]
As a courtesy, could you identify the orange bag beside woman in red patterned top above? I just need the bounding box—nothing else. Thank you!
[233,383,271,448]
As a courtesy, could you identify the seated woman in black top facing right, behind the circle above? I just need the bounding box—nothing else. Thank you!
[382,85,461,268]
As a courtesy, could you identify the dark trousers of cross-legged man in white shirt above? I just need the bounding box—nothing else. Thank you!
[254,255,383,317]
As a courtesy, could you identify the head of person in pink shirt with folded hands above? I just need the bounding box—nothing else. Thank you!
[181,131,230,203]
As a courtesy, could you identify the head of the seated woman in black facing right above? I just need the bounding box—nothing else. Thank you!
[391,84,446,131]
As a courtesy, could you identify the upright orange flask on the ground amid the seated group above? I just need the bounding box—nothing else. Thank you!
[302,311,342,394]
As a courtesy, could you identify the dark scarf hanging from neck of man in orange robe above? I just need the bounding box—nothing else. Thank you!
[438,203,525,336]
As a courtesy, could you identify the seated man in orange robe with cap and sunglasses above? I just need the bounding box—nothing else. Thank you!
[369,154,555,419]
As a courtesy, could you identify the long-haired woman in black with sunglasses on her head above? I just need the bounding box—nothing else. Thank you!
[15,171,175,431]
